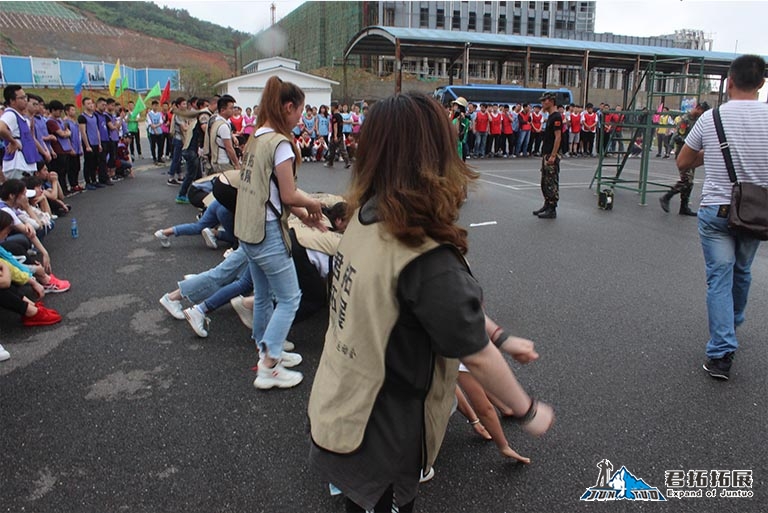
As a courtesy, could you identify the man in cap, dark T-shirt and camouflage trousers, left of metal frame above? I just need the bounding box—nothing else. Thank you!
[533,93,563,219]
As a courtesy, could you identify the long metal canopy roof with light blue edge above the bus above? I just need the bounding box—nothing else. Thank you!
[344,26,768,96]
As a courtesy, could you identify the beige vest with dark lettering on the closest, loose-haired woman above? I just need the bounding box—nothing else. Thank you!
[309,212,458,466]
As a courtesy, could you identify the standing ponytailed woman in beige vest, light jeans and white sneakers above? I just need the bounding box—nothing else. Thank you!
[235,76,325,389]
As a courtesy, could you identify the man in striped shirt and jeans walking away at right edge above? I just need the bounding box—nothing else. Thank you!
[677,55,768,380]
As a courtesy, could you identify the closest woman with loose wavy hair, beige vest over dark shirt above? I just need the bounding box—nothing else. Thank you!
[309,93,554,513]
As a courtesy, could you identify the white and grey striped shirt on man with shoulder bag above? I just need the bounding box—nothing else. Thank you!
[685,100,768,205]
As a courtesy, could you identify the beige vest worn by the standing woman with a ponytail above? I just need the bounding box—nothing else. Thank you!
[235,132,296,249]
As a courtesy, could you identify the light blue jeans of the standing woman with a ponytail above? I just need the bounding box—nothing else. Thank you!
[240,220,301,359]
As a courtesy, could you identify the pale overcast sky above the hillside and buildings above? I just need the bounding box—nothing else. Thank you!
[155,0,768,55]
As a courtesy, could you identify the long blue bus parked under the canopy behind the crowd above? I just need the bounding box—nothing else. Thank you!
[433,84,573,106]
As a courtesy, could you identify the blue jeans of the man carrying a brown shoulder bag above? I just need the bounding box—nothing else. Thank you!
[699,205,760,358]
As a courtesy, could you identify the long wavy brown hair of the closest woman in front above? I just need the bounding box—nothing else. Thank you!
[348,93,478,253]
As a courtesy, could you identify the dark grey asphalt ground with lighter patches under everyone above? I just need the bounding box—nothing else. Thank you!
[0,149,768,513]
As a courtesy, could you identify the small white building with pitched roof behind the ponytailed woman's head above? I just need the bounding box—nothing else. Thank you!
[216,57,339,110]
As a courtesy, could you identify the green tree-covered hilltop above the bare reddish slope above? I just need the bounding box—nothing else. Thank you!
[62,2,250,55]
